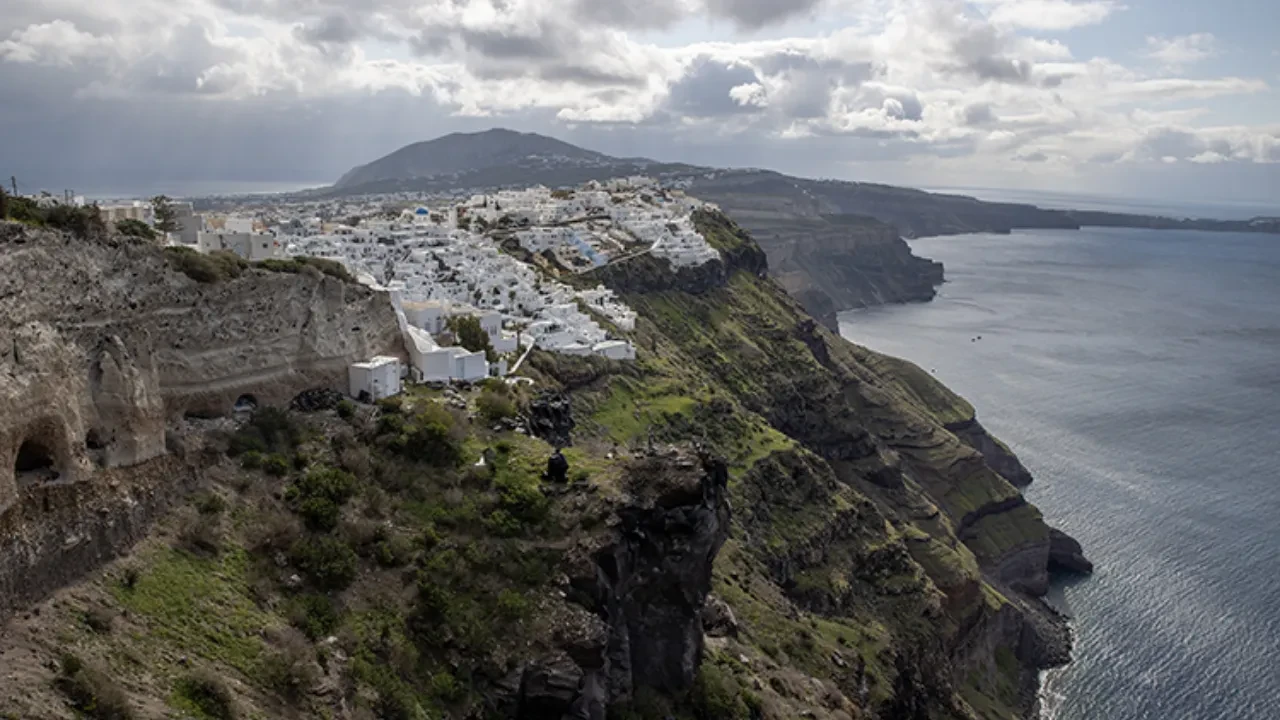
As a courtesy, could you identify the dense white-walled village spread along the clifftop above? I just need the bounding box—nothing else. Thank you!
[77,177,718,400]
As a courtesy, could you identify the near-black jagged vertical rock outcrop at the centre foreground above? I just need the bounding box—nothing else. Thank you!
[494,450,730,720]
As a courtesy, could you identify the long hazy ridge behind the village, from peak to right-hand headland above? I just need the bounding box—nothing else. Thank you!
[332,129,1280,327]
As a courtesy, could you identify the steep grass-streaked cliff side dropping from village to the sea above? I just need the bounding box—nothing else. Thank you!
[550,208,1090,717]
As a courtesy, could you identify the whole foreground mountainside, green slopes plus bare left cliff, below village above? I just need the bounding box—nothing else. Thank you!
[0,219,1088,720]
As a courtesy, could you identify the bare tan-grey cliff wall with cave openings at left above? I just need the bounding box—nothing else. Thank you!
[0,223,399,607]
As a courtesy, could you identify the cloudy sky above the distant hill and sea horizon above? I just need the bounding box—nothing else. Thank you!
[0,0,1280,202]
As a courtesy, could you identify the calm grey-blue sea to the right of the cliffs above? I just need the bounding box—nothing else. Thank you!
[841,228,1280,720]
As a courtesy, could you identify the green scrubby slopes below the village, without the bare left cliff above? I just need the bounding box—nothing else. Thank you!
[0,214,1066,720]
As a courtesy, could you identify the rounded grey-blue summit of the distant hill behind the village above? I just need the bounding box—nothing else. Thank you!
[334,129,614,188]
